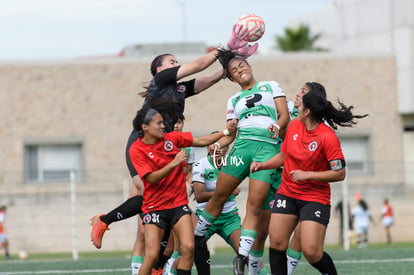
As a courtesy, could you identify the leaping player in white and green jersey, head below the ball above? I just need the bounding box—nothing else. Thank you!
[194,51,289,274]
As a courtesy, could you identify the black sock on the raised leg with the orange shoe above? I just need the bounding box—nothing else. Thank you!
[101,196,143,225]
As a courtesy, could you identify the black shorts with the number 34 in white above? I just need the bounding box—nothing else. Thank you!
[272,193,331,226]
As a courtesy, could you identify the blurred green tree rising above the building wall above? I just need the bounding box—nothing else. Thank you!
[276,24,327,52]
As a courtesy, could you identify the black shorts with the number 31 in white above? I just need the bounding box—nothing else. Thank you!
[142,204,191,230]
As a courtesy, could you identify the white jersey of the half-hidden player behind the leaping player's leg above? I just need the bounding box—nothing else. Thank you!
[193,156,237,213]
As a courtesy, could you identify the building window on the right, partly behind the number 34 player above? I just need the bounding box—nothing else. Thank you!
[340,137,370,174]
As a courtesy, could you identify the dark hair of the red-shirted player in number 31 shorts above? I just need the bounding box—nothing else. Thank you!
[132,97,178,136]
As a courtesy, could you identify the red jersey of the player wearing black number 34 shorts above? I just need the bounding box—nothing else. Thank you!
[277,119,344,204]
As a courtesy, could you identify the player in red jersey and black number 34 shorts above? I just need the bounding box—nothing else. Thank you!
[251,82,367,275]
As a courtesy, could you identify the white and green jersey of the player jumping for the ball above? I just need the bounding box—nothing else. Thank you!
[227,81,286,144]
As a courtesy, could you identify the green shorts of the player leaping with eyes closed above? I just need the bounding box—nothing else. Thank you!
[221,138,280,184]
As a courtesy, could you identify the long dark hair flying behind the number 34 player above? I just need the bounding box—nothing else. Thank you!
[302,82,368,130]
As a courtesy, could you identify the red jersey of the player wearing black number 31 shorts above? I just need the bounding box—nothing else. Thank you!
[129,132,193,214]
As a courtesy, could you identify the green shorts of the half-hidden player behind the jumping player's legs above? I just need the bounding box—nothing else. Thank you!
[196,208,241,249]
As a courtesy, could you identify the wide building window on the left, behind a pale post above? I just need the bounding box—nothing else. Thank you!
[24,143,82,183]
